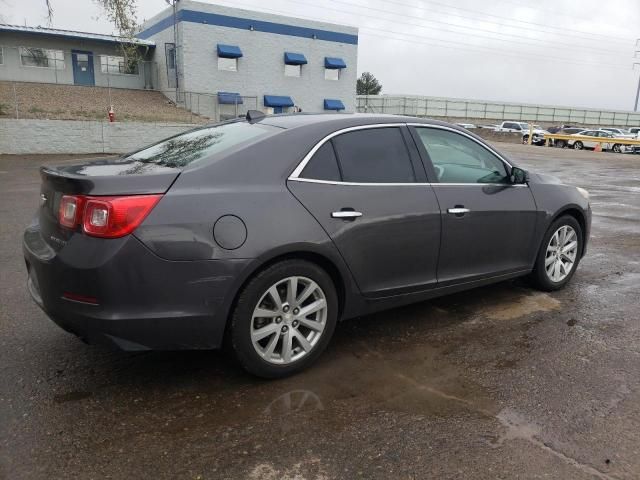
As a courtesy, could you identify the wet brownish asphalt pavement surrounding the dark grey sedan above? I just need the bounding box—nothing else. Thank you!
[0,144,640,479]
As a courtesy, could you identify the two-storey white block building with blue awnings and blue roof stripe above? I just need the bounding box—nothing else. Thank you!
[137,0,358,117]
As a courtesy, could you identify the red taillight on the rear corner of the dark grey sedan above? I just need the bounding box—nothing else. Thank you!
[59,195,162,238]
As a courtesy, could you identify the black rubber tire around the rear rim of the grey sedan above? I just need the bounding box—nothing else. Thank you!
[229,259,338,378]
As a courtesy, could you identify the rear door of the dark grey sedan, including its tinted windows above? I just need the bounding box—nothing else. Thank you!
[287,125,440,297]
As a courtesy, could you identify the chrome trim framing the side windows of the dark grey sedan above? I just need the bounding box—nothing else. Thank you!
[287,122,529,187]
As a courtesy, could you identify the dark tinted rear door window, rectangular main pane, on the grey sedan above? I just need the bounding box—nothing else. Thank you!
[333,127,416,183]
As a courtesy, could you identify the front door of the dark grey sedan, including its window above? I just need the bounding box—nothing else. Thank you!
[412,125,537,286]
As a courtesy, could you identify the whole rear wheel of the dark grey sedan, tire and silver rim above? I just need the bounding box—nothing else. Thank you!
[230,259,338,378]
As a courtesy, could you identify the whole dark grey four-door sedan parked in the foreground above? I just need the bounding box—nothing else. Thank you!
[23,112,591,378]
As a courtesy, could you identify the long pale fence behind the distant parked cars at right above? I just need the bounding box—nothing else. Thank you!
[356,95,640,127]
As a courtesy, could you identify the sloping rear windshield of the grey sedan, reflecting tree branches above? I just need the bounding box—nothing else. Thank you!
[124,122,277,168]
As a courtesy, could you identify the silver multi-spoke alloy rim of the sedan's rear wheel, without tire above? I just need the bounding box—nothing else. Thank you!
[250,276,327,365]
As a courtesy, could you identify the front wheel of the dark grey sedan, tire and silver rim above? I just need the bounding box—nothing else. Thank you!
[531,215,583,292]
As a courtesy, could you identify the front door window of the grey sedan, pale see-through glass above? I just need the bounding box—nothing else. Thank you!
[416,128,509,183]
